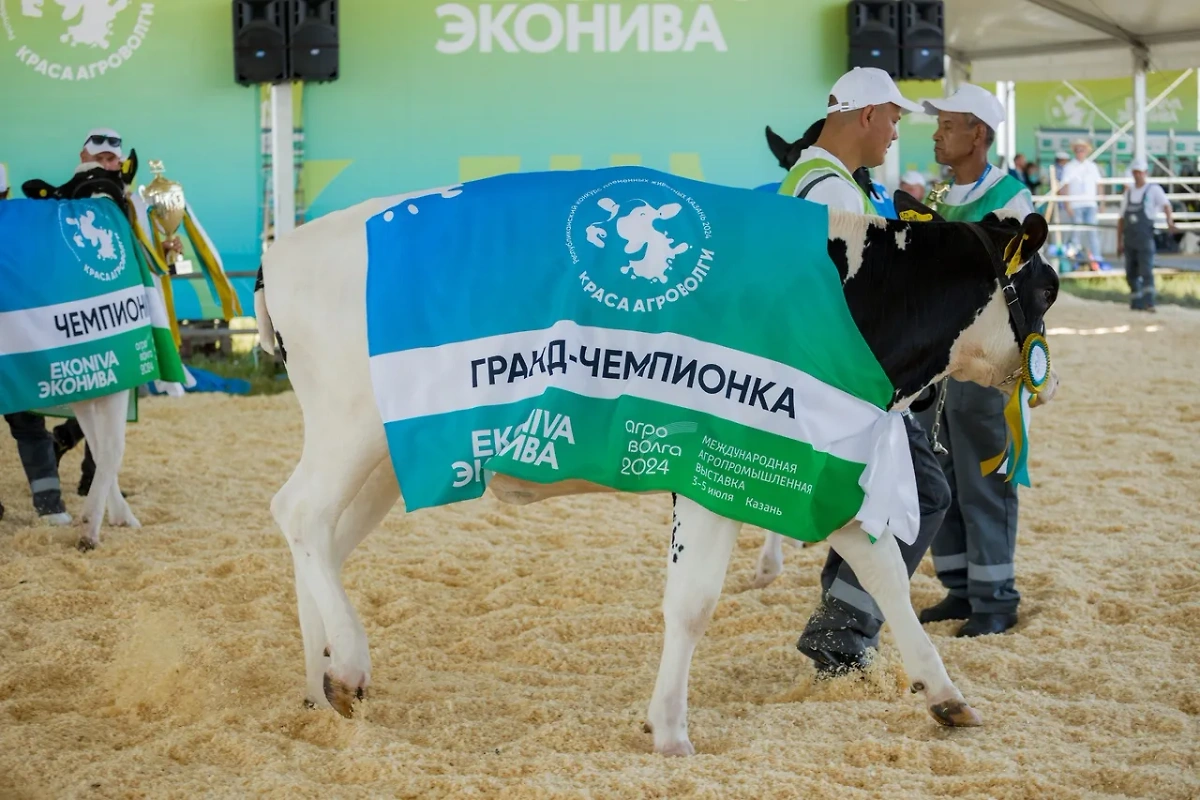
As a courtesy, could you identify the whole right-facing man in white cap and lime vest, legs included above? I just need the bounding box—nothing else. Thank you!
[782,67,950,679]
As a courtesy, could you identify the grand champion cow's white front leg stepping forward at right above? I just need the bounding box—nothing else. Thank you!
[829,525,983,727]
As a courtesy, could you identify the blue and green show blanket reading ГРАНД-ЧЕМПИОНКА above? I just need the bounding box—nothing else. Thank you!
[366,167,918,541]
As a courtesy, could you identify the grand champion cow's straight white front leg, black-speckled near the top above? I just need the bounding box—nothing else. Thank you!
[647,495,742,756]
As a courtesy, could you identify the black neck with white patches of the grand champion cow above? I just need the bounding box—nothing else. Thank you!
[828,211,1007,408]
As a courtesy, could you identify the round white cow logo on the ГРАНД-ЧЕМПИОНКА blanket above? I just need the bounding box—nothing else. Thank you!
[566,178,715,312]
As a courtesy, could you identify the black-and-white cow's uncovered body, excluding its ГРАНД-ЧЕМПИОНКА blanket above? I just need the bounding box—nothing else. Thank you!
[254,179,1058,754]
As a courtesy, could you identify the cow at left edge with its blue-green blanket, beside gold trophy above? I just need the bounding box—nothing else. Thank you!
[0,159,184,551]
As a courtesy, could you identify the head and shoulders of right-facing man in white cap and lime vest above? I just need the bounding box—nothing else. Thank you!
[779,67,922,215]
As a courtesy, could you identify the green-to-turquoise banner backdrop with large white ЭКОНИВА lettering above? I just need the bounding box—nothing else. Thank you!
[0,0,1196,284]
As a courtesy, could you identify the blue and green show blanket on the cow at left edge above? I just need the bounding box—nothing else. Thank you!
[0,198,184,414]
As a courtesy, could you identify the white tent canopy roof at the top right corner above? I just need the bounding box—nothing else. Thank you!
[944,0,1200,84]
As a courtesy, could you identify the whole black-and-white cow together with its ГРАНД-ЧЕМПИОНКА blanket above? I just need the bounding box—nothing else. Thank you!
[256,167,1057,754]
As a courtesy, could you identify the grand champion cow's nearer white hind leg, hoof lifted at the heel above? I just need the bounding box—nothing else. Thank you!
[271,419,386,716]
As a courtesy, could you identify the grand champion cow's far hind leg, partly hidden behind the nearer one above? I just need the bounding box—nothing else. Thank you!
[296,458,400,708]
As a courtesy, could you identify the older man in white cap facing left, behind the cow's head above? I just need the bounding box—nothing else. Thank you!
[917,84,1033,637]
